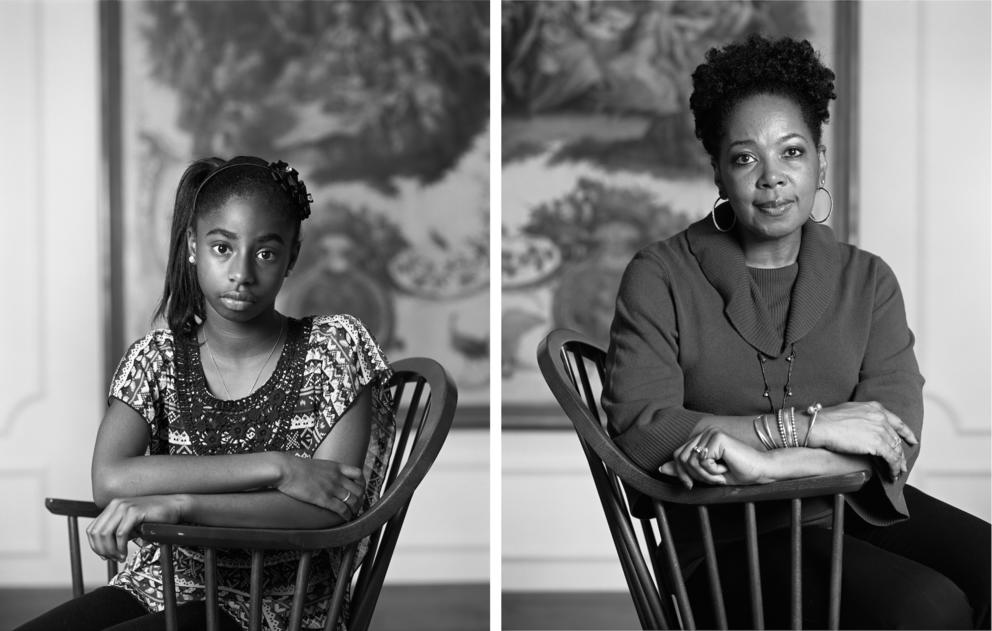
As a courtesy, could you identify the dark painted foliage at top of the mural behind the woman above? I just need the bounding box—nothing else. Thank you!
[502,0,809,174]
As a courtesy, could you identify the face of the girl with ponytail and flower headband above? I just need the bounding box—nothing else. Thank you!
[186,197,300,322]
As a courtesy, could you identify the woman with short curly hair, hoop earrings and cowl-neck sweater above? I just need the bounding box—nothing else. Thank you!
[603,36,992,629]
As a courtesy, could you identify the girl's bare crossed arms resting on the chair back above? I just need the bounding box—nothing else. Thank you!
[86,388,372,561]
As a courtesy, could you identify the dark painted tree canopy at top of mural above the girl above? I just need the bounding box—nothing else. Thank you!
[143,1,489,190]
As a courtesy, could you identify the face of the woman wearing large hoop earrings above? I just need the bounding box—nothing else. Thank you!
[713,94,827,241]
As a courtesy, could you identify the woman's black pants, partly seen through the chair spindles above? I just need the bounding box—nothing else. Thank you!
[688,486,992,629]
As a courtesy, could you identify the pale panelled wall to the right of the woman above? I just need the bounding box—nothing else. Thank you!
[860,2,992,519]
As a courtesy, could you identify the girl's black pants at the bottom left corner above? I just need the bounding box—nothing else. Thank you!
[14,587,241,631]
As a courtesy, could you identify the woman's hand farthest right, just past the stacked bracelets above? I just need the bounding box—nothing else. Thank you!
[809,401,920,479]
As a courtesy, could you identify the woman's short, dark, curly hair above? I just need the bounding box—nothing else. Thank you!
[689,35,837,160]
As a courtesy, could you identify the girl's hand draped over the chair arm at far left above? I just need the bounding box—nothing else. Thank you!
[86,495,186,561]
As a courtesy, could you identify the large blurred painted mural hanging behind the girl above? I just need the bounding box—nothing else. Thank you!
[103,0,489,420]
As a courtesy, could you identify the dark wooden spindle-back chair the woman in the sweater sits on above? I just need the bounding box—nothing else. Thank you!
[537,329,871,629]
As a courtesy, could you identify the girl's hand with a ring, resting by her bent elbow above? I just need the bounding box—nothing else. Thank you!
[276,453,365,521]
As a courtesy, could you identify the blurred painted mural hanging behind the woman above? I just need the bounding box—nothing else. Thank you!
[501,1,844,426]
